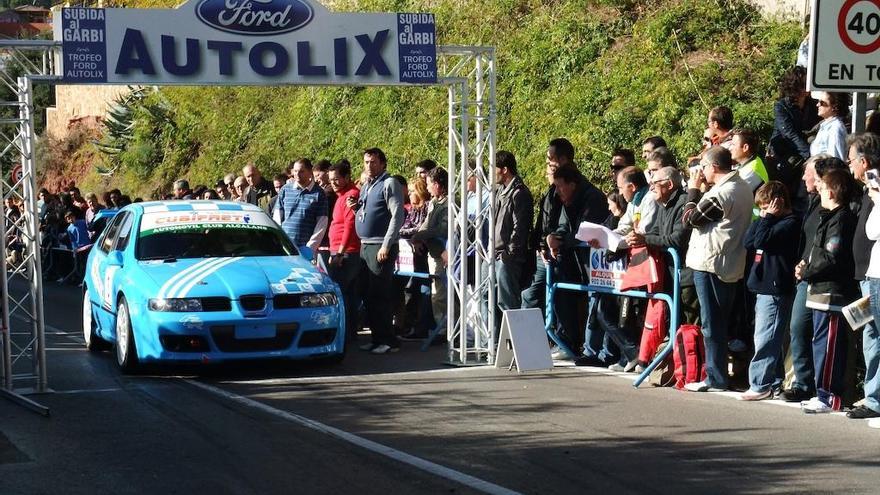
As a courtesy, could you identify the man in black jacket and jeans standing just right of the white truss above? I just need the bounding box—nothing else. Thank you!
[493,151,535,329]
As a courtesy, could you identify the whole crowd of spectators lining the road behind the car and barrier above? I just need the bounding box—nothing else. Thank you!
[17,53,880,430]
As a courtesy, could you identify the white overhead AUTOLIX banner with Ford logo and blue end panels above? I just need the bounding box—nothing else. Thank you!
[54,0,437,86]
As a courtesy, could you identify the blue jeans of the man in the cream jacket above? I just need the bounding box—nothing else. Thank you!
[694,270,736,389]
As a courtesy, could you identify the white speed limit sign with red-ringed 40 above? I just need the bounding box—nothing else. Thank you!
[807,0,880,92]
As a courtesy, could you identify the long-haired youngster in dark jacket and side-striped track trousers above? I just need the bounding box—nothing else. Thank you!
[795,169,856,414]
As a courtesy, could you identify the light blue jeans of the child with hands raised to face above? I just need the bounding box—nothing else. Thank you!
[749,294,794,392]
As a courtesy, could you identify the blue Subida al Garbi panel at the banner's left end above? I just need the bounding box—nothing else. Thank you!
[61,8,107,83]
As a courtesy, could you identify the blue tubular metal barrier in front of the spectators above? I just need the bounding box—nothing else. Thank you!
[545,244,681,388]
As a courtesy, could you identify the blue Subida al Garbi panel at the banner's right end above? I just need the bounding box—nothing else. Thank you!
[397,14,437,84]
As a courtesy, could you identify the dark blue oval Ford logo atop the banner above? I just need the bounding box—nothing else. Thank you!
[196,0,314,36]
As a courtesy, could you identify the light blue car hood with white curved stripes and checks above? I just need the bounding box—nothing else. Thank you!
[140,256,335,299]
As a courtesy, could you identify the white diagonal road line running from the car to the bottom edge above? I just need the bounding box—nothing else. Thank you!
[186,380,519,495]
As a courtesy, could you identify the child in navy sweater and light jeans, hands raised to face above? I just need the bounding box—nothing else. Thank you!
[739,181,800,401]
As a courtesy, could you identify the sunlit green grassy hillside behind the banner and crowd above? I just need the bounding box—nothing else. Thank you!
[46,0,803,197]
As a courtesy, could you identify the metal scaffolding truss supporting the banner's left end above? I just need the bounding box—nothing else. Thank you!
[0,40,59,409]
